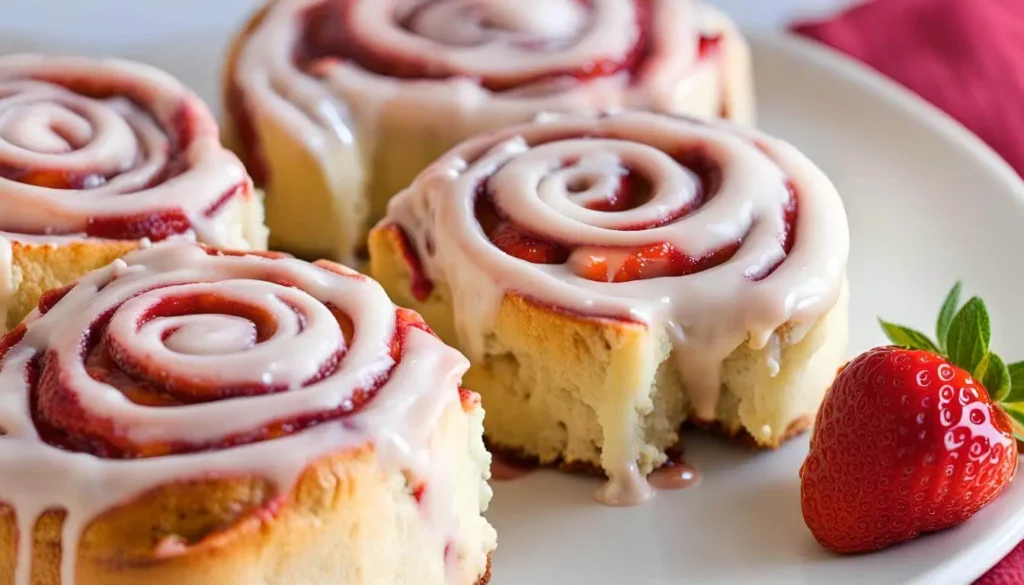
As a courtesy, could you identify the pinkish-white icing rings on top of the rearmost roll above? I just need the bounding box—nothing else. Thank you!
[234,0,737,131]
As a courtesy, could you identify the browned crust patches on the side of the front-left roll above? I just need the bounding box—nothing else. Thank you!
[0,448,352,585]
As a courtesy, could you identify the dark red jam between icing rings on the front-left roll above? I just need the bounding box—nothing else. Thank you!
[0,244,436,459]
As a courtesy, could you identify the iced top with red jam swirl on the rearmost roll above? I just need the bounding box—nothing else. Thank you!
[227,0,721,180]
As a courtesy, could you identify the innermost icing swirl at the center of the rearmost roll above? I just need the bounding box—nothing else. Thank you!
[349,0,634,80]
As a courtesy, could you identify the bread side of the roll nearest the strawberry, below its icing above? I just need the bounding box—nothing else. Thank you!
[370,227,847,472]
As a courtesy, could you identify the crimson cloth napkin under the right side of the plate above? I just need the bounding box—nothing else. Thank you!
[793,0,1024,585]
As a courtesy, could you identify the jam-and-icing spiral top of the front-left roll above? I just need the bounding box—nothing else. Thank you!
[0,246,429,459]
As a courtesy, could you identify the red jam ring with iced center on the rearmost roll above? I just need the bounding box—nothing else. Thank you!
[225,0,726,183]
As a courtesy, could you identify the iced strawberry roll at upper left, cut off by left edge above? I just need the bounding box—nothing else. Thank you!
[0,55,266,332]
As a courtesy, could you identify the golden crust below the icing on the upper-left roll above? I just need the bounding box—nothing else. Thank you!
[0,240,139,331]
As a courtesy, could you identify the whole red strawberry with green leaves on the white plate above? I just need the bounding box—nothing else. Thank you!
[800,284,1024,553]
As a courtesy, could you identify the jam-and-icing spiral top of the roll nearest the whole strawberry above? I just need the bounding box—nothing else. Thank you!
[391,117,800,300]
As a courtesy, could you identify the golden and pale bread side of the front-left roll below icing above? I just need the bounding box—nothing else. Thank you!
[0,405,489,585]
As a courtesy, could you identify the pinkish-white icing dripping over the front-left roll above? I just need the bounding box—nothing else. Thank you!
[0,243,468,585]
